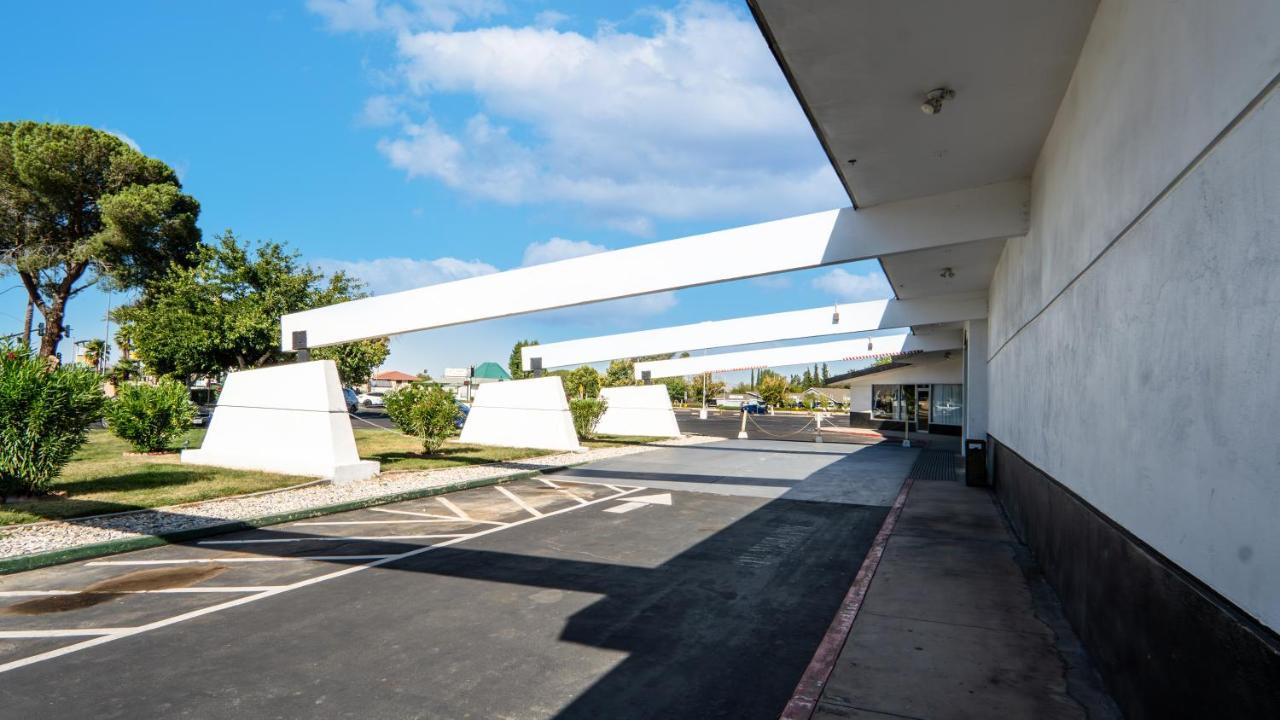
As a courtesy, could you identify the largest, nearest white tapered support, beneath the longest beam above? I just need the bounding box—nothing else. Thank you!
[182,360,379,482]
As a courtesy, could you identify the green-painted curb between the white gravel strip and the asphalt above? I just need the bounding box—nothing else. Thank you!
[0,461,588,575]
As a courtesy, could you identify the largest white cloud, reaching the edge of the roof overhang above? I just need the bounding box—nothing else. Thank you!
[312,0,847,234]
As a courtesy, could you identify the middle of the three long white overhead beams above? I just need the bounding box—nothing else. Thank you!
[521,290,987,370]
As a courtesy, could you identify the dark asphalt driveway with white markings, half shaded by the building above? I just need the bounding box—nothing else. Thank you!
[0,441,916,719]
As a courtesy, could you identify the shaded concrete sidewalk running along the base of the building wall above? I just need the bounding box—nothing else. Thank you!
[813,451,1120,720]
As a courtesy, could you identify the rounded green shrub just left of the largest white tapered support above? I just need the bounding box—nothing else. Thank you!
[106,380,196,452]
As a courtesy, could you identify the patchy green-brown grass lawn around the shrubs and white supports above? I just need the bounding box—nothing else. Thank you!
[0,429,655,525]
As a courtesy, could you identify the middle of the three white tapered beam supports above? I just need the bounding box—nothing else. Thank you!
[461,375,582,450]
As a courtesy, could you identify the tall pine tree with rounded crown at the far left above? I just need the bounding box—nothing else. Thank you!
[0,122,200,356]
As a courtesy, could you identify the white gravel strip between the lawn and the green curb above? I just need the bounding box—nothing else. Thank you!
[0,436,722,574]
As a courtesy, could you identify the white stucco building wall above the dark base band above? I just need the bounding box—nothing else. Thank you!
[988,0,1280,629]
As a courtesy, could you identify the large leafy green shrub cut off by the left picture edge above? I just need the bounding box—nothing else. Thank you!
[0,347,106,495]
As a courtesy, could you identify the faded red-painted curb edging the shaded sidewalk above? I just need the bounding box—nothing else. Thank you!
[780,478,913,720]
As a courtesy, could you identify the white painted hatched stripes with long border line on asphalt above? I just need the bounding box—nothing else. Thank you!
[0,480,646,674]
